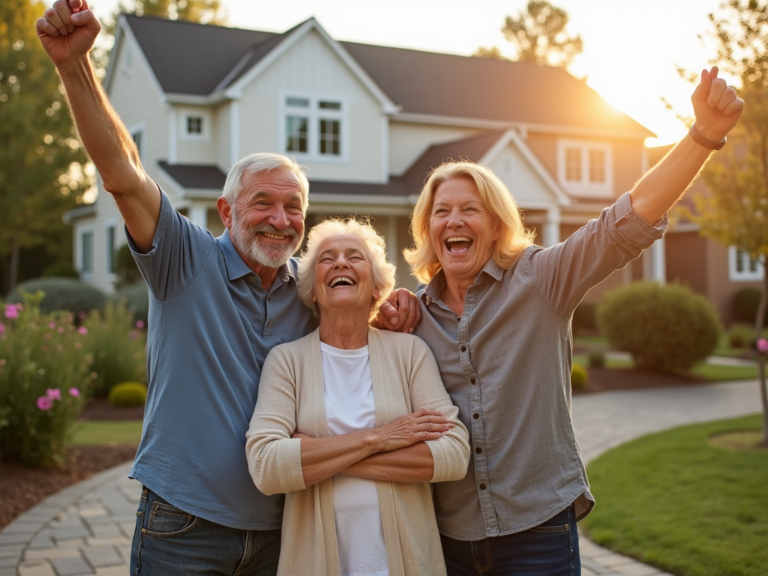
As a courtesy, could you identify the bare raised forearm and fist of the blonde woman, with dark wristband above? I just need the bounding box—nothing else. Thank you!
[630,67,744,224]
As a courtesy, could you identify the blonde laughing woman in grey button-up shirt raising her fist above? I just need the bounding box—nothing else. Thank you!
[406,69,743,576]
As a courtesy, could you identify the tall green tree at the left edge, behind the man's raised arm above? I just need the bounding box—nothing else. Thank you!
[0,0,88,290]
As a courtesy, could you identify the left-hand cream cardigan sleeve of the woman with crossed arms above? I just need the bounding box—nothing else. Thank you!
[245,349,306,496]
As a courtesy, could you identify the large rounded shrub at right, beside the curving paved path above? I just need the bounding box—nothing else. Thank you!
[597,282,720,372]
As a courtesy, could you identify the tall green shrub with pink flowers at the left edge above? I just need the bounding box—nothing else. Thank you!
[0,293,91,466]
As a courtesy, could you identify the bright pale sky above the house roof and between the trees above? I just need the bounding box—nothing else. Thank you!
[91,0,720,146]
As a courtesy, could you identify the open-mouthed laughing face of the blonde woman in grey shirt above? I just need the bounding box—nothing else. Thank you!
[429,178,499,283]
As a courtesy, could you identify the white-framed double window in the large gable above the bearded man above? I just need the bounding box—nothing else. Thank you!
[282,96,348,159]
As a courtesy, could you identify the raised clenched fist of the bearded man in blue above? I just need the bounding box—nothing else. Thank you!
[36,0,101,66]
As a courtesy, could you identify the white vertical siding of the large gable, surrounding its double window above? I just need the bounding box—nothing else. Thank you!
[238,31,386,183]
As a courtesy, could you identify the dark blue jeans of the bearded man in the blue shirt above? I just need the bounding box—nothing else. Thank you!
[131,488,280,576]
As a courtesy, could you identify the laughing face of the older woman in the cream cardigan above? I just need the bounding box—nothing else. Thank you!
[313,235,379,323]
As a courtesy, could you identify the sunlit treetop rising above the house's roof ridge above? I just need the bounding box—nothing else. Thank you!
[475,0,584,68]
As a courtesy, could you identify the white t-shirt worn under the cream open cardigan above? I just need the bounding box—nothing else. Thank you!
[320,342,389,576]
